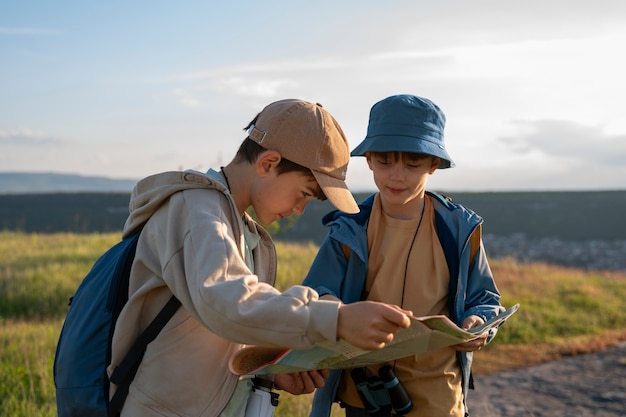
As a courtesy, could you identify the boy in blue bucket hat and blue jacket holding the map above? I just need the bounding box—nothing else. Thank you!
[304,95,504,417]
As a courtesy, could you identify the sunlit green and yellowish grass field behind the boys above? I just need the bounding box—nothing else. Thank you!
[0,232,626,417]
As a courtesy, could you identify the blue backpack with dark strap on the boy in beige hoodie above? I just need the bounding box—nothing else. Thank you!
[54,232,180,417]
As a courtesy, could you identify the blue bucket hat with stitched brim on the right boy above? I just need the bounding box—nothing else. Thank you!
[350,94,454,169]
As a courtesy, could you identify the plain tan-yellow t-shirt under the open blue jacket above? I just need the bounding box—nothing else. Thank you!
[338,195,464,417]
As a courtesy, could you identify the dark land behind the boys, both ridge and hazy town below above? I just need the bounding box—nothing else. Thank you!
[0,186,626,271]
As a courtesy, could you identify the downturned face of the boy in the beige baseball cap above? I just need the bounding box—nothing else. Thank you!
[251,169,323,224]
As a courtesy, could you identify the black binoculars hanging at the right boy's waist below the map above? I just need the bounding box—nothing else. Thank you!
[350,365,413,415]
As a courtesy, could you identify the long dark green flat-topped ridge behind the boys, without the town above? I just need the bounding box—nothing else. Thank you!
[0,183,626,243]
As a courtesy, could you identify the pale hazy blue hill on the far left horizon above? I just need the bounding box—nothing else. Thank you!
[0,172,137,194]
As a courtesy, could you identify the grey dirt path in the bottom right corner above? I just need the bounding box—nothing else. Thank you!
[468,342,626,417]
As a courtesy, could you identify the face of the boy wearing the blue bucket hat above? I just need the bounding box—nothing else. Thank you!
[366,152,440,218]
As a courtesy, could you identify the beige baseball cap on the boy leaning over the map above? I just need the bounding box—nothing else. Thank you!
[248,99,359,213]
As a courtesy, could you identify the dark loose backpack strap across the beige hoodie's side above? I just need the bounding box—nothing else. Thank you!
[108,295,181,417]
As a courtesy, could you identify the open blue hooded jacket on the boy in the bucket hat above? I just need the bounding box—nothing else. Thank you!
[303,192,504,417]
